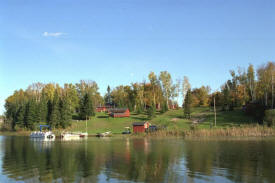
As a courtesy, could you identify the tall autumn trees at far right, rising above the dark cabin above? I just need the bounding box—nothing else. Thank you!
[210,62,275,123]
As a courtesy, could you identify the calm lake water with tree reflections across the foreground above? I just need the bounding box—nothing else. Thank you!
[0,136,275,183]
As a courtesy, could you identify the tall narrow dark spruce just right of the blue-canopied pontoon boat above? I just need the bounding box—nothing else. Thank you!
[49,91,60,128]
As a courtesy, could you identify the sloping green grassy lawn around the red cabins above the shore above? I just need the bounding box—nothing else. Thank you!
[67,107,255,134]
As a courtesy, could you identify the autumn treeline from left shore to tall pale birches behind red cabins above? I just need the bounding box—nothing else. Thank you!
[5,71,191,129]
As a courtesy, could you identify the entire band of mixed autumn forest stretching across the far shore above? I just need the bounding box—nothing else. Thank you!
[5,62,275,129]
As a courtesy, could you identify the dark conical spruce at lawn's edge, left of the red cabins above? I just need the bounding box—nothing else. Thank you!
[80,93,95,120]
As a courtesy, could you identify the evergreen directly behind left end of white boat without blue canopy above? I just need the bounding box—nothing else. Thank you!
[59,97,72,128]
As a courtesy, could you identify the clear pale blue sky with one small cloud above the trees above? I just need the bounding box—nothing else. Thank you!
[0,0,275,113]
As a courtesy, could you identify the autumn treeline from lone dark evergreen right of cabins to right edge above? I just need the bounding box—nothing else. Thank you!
[184,62,275,126]
